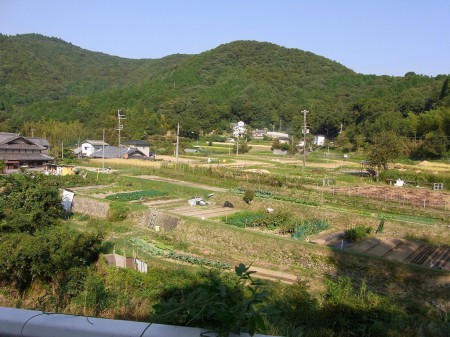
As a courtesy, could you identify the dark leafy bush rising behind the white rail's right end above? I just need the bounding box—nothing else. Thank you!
[154,263,268,336]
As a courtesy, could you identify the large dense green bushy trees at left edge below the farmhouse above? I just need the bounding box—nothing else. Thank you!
[0,174,102,289]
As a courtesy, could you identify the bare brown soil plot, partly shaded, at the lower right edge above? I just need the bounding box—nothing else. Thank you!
[351,238,450,270]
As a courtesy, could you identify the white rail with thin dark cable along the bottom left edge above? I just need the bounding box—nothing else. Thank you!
[0,307,274,337]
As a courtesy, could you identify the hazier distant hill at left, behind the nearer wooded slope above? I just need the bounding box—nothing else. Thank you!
[0,34,188,107]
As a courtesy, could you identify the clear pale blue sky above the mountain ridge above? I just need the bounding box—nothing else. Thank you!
[0,0,450,76]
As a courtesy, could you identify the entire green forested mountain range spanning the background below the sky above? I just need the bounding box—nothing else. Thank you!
[0,34,450,158]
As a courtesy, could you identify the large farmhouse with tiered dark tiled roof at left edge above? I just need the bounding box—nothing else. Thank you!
[0,132,53,170]
